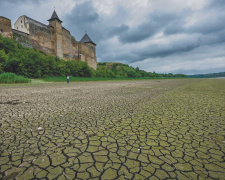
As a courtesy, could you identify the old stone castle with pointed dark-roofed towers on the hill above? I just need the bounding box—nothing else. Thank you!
[0,10,97,70]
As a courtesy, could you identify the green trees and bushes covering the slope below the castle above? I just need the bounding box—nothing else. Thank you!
[0,34,186,78]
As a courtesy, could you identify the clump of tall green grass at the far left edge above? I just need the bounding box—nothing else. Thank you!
[0,73,31,84]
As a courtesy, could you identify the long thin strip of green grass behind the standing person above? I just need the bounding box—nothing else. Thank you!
[43,76,186,82]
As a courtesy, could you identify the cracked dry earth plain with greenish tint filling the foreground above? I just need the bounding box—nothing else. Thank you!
[0,79,225,180]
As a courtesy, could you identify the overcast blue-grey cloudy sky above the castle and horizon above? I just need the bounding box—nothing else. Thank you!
[0,0,225,74]
